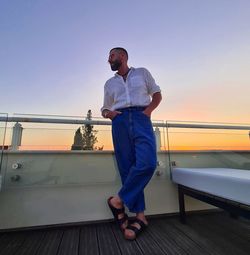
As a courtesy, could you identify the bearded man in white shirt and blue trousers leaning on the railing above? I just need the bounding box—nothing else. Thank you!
[101,47,162,240]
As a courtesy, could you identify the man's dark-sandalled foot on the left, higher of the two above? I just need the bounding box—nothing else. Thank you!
[107,197,128,231]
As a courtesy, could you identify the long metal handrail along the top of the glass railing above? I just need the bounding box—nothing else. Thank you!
[0,117,250,130]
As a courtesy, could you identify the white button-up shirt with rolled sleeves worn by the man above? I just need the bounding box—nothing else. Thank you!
[101,67,161,112]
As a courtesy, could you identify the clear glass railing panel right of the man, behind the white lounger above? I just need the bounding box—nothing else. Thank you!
[167,122,250,170]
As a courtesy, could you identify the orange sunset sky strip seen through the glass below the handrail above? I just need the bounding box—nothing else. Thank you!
[2,121,250,151]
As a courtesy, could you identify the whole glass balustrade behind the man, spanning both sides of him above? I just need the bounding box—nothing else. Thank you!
[0,115,250,189]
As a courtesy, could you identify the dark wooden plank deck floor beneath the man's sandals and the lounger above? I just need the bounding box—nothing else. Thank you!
[0,212,250,255]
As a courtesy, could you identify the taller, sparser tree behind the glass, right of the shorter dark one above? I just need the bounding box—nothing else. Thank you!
[82,110,98,150]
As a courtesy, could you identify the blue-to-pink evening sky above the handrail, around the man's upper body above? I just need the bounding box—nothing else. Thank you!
[0,0,250,123]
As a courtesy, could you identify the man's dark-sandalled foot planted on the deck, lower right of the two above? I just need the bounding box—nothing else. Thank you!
[124,218,148,240]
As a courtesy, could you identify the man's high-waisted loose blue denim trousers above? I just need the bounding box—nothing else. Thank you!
[112,107,157,213]
